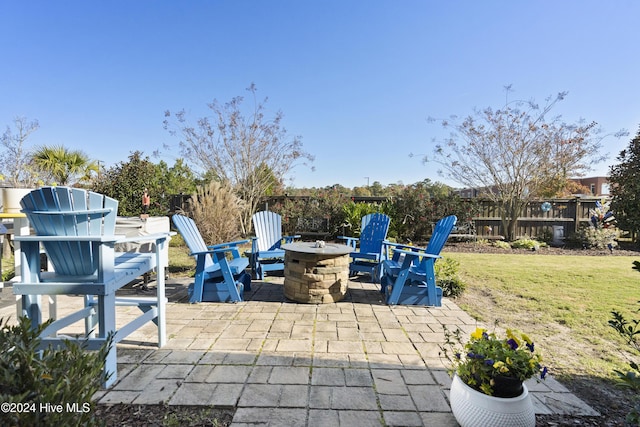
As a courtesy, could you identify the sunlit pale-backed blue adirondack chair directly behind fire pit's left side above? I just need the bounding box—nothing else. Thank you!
[249,211,300,280]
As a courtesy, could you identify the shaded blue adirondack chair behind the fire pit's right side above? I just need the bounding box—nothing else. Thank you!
[338,213,390,282]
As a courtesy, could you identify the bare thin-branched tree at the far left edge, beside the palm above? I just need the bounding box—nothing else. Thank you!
[0,117,40,187]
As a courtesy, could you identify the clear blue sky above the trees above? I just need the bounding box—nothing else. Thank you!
[0,0,640,187]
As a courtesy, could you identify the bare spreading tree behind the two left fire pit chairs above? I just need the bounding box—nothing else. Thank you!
[164,84,313,234]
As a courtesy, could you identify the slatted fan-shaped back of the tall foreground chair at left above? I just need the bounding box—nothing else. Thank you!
[20,187,118,276]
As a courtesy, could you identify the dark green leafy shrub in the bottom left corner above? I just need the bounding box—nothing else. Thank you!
[0,317,111,426]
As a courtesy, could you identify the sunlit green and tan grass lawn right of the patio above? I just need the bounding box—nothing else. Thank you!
[443,253,640,378]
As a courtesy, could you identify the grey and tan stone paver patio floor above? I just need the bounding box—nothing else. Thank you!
[0,277,598,427]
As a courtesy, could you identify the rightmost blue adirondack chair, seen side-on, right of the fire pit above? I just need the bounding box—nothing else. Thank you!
[381,215,457,307]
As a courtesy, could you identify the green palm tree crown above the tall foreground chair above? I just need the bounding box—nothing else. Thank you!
[31,145,98,185]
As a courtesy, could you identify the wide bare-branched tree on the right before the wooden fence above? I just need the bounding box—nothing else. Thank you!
[424,86,624,240]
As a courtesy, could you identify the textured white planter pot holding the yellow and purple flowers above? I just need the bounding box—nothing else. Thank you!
[450,375,536,427]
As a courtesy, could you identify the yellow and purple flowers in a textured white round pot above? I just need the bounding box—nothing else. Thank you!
[440,327,547,427]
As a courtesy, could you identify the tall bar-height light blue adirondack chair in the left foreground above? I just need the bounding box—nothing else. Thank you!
[13,187,169,387]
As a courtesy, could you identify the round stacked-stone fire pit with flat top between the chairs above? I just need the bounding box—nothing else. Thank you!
[282,242,353,304]
